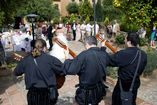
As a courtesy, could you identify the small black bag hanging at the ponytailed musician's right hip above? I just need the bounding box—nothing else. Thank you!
[49,87,58,103]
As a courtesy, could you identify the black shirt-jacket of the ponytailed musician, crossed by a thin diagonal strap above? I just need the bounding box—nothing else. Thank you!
[14,52,63,89]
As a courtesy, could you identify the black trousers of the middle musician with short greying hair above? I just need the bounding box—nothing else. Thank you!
[75,83,106,105]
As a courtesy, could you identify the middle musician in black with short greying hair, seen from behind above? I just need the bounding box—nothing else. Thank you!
[64,36,107,105]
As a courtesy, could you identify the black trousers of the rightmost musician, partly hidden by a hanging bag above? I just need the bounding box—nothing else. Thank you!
[112,81,139,105]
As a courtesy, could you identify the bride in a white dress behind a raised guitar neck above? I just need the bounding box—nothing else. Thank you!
[49,24,68,60]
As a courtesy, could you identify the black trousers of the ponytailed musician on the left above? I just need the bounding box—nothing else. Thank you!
[27,88,57,105]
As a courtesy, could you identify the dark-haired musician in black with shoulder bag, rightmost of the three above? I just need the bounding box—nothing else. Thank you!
[102,32,147,105]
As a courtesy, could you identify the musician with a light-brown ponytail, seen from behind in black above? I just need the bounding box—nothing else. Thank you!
[14,39,63,105]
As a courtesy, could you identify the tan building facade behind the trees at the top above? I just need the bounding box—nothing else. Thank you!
[53,0,97,16]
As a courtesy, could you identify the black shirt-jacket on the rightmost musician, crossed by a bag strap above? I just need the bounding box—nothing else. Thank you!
[106,47,147,81]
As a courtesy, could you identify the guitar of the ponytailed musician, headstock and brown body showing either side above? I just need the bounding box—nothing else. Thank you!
[12,53,65,89]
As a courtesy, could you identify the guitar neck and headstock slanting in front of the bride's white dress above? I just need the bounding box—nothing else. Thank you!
[54,38,77,58]
